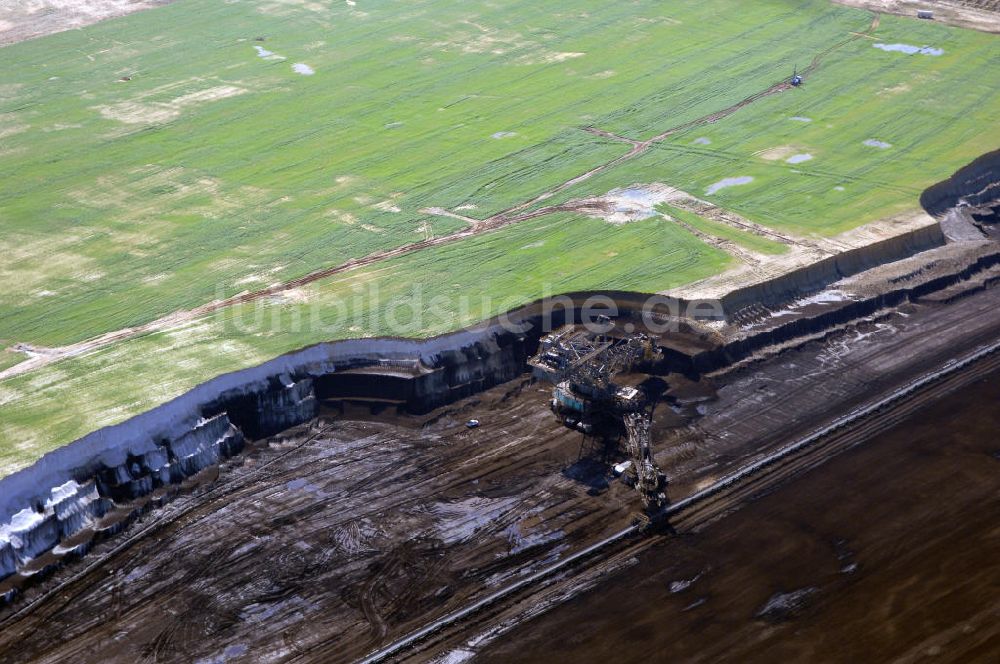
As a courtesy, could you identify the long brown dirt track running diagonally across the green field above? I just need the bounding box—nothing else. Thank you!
[0,13,881,381]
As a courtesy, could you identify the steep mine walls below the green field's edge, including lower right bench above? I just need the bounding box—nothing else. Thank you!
[0,153,1000,596]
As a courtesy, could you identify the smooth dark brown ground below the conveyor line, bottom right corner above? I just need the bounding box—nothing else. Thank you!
[475,374,1000,663]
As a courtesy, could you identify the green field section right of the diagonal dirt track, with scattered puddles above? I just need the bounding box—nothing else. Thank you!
[540,10,1000,235]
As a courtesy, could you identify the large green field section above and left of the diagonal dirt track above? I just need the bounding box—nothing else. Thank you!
[0,0,852,345]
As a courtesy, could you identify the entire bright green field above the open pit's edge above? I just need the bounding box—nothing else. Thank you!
[0,0,1000,475]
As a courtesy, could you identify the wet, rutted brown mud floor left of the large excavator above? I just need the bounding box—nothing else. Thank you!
[0,383,631,662]
